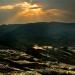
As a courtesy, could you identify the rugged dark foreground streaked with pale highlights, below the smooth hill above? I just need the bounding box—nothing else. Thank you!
[0,47,75,75]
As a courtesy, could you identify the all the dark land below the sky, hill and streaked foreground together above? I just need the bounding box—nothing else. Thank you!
[0,22,75,75]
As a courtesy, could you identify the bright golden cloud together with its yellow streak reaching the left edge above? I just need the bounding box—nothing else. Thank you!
[0,2,43,15]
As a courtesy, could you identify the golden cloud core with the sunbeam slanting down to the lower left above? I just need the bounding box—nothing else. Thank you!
[6,2,43,23]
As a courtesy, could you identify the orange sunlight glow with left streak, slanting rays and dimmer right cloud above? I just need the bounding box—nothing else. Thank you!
[0,2,68,23]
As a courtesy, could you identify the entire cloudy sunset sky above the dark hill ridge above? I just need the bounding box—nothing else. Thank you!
[0,0,75,24]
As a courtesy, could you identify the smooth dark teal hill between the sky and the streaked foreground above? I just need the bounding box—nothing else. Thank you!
[0,22,75,48]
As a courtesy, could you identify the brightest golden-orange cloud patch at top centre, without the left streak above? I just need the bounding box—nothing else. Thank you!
[16,2,43,16]
